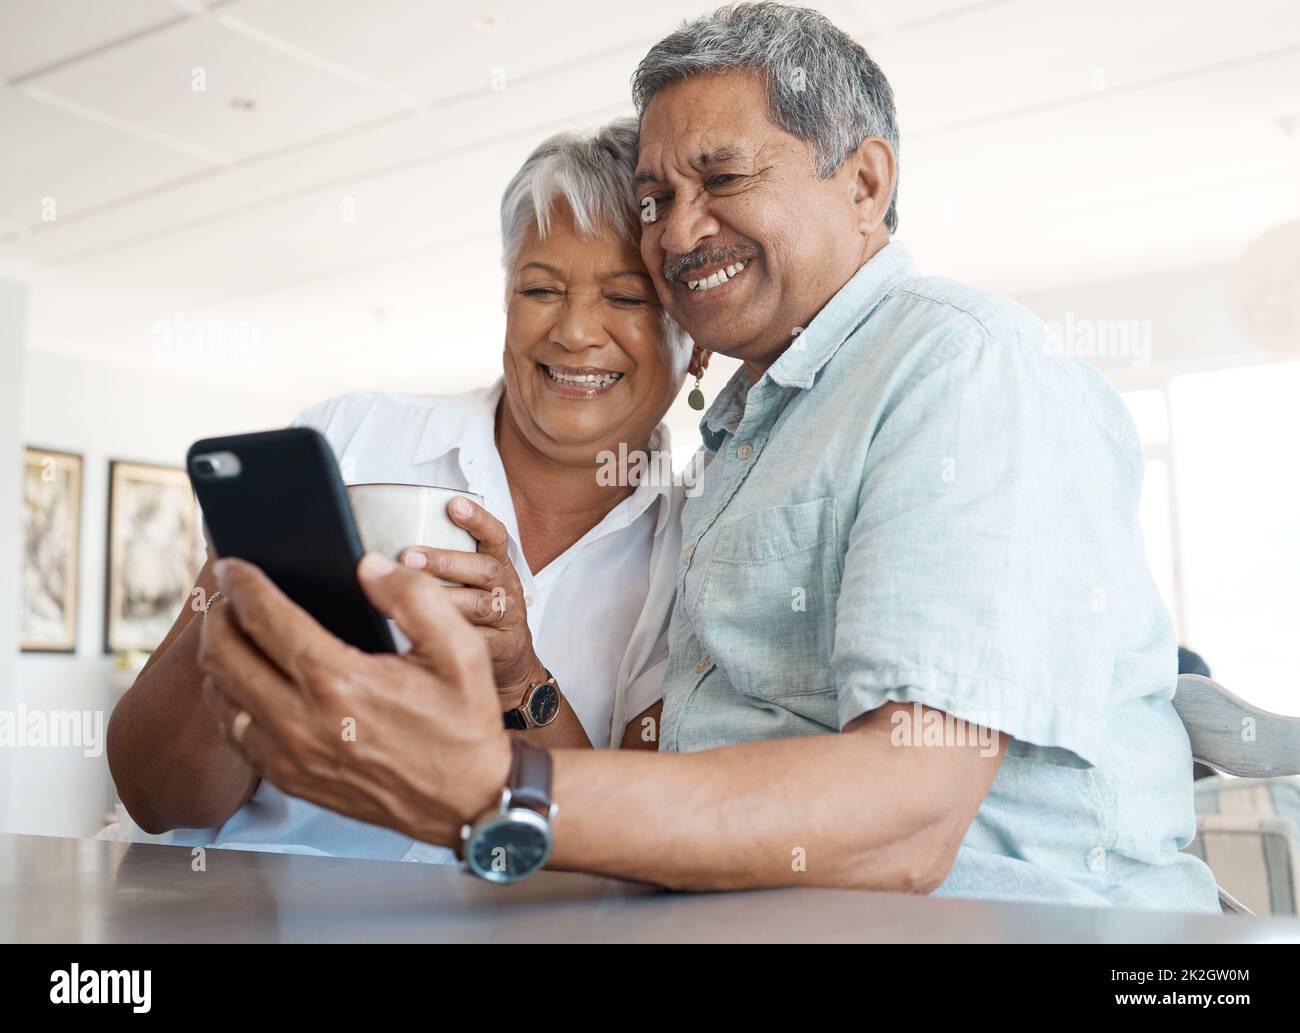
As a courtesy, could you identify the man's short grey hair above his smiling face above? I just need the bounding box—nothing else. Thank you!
[632,3,898,233]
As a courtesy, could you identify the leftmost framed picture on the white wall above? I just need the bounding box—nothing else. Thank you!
[18,448,82,652]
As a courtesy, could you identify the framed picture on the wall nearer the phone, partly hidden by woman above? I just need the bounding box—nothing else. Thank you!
[104,460,202,652]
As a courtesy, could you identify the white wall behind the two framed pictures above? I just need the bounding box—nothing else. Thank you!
[12,351,303,835]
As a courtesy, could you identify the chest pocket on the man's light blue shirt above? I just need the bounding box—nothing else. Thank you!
[694,498,841,700]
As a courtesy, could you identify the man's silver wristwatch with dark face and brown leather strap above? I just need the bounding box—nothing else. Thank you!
[460,735,558,884]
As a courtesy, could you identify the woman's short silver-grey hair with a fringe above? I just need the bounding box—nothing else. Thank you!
[501,117,689,344]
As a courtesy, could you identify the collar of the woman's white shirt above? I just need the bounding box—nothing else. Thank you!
[415,377,675,535]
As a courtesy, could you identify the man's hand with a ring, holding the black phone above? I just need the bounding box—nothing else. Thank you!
[199,554,511,846]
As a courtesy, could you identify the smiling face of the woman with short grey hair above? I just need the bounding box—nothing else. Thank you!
[504,199,690,465]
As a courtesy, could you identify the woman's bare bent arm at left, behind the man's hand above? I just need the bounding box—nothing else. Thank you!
[107,568,259,833]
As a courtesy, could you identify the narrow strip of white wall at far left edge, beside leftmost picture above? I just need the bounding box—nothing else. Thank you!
[0,279,27,829]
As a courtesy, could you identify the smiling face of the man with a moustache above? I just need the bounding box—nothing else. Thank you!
[636,71,871,381]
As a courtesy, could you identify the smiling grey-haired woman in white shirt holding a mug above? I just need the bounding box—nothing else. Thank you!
[108,118,709,860]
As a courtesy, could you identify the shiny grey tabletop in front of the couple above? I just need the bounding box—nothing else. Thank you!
[0,835,1300,943]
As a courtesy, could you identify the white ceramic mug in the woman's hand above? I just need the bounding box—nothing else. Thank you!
[347,483,484,585]
